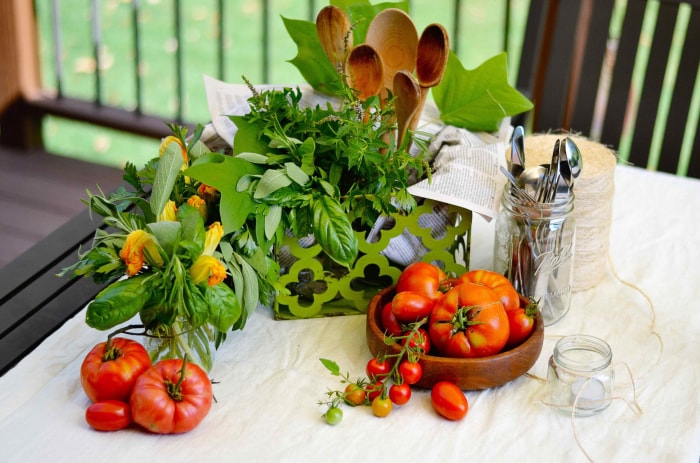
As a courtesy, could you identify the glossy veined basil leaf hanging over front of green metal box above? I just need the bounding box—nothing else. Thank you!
[313,196,357,268]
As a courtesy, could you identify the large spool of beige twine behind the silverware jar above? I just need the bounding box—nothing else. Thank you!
[525,133,617,291]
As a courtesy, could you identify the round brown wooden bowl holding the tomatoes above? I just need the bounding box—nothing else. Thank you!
[366,286,544,391]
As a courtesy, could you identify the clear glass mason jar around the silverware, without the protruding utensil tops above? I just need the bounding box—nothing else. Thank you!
[494,188,576,326]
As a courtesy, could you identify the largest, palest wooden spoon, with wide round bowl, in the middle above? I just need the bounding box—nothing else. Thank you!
[365,8,418,96]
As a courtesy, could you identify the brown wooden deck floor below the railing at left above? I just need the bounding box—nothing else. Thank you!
[0,147,123,267]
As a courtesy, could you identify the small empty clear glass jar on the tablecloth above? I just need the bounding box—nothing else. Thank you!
[546,334,615,416]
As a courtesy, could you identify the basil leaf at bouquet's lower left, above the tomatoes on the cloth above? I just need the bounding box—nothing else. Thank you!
[85,275,151,330]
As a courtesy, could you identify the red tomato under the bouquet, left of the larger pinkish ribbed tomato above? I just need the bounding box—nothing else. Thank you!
[80,338,151,402]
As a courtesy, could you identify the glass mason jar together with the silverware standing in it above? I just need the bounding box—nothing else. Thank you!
[494,127,581,326]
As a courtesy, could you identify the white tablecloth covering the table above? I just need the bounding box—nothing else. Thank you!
[0,167,700,463]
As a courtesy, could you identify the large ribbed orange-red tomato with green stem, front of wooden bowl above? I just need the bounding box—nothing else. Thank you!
[429,283,510,358]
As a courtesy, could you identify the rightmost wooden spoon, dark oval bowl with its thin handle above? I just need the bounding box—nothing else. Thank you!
[410,23,450,130]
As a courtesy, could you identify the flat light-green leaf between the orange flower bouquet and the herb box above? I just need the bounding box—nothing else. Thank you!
[185,156,262,233]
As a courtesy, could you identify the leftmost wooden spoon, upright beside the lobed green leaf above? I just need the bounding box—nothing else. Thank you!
[316,5,353,71]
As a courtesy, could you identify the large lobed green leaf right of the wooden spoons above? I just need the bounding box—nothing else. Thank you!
[433,52,532,132]
